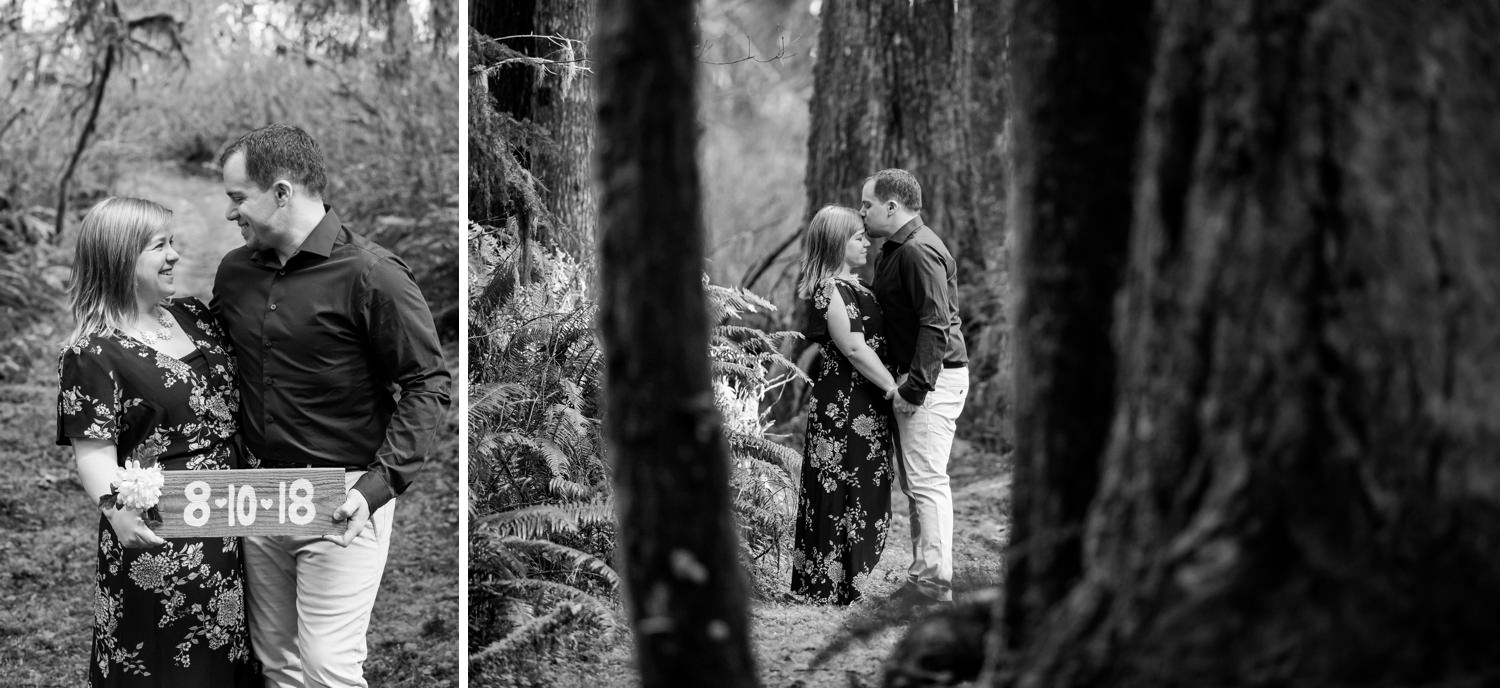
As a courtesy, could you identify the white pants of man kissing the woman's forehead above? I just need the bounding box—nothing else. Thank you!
[896,367,969,601]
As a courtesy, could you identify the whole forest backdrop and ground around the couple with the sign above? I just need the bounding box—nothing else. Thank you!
[0,0,461,687]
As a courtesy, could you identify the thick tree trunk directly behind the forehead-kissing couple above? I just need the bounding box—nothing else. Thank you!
[791,0,1011,440]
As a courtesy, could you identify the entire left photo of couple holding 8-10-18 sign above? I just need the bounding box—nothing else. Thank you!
[0,0,462,688]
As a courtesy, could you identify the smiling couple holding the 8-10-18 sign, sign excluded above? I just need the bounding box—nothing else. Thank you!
[57,124,450,687]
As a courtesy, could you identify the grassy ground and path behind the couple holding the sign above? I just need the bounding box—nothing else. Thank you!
[0,168,464,688]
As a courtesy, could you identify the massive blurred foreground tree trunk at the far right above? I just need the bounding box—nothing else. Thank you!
[1010,0,1500,687]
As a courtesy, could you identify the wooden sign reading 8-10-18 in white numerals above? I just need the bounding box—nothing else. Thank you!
[155,468,347,538]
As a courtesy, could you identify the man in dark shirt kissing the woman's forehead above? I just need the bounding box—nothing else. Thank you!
[860,169,969,604]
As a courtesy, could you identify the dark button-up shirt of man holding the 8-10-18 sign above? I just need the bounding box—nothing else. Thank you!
[212,210,452,511]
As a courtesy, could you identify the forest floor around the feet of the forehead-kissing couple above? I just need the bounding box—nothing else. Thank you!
[486,439,1011,688]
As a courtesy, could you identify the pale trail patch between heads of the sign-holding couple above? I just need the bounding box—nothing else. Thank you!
[114,163,245,303]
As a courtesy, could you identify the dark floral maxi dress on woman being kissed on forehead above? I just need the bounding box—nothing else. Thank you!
[792,279,894,604]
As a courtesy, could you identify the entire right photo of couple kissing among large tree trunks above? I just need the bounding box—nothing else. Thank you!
[465,0,1500,688]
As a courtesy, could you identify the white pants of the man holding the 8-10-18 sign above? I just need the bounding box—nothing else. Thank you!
[245,471,396,688]
